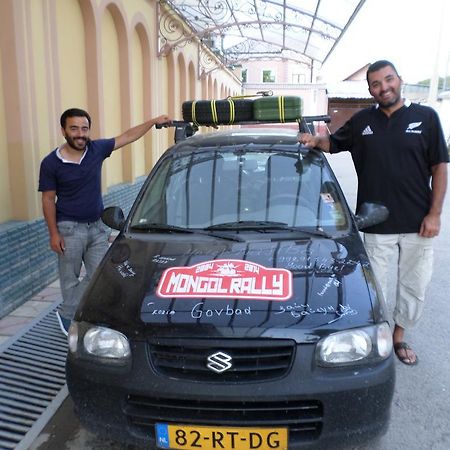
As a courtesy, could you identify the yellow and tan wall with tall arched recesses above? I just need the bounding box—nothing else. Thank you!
[0,0,240,223]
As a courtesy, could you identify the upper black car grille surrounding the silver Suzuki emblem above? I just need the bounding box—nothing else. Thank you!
[149,338,295,383]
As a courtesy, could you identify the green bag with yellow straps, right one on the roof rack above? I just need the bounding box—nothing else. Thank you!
[253,96,302,122]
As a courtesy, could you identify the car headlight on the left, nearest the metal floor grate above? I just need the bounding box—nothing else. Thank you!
[83,326,131,360]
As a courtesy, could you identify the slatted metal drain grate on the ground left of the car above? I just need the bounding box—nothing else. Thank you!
[0,301,67,450]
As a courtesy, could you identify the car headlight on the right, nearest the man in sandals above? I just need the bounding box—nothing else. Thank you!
[316,322,392,366]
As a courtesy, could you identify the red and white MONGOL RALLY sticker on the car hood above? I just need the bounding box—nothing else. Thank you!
[156,259,292,301]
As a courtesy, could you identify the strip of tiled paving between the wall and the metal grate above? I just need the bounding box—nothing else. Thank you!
[0,280,61,345]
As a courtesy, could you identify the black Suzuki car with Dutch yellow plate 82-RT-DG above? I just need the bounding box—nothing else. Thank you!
[67,123,395,450]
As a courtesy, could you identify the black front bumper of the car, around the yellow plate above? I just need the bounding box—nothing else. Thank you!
[66,342,395,450]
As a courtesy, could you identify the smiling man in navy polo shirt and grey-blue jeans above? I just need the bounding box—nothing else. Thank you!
[39,108,170,335]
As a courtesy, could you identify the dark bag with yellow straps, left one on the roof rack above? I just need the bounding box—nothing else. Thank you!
[182,97,253,125]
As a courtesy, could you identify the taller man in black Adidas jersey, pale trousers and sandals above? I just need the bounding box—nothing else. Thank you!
[299,60,449,365]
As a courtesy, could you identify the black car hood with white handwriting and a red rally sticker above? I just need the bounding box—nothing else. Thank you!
[76,234,383,341]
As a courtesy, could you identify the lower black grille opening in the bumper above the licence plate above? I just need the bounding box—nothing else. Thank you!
[124,395,323,441]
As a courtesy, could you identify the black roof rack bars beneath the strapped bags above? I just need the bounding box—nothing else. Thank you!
[156,115,331,143]
